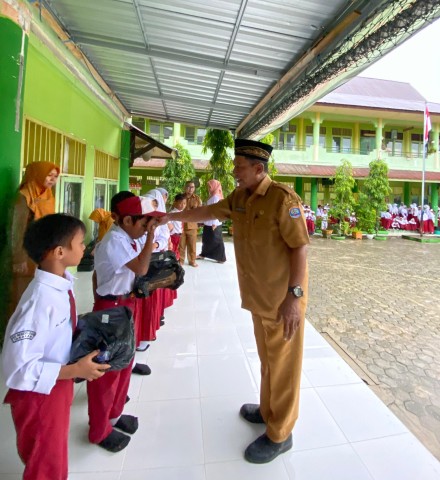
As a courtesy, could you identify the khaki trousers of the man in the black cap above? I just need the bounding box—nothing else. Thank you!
[252,309,305,442]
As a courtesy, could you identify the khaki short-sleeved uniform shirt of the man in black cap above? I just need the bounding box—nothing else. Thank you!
[210,176,309,318]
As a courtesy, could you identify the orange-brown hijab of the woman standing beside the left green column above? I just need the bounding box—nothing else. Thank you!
[19,162,60,220]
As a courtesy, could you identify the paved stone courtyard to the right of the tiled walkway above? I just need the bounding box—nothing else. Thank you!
[307,236,440,459]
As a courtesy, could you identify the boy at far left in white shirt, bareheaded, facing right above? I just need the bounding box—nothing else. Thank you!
[3,214,110,480]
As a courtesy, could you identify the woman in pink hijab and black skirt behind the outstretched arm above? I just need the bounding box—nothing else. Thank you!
[197,179,226,263]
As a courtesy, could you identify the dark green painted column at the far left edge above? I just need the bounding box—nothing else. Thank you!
[0,17,28,342]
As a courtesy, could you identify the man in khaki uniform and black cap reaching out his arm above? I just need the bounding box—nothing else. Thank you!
[162,139,309,463]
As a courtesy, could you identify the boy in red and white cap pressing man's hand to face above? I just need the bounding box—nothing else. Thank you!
[87,192,165,452]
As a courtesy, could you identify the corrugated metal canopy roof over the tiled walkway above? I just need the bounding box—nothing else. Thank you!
[43,0,440,137]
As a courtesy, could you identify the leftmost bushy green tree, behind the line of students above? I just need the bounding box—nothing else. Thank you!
[162,143,196,203]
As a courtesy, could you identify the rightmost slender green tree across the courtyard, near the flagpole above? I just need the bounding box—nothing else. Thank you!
[362,160,391,232]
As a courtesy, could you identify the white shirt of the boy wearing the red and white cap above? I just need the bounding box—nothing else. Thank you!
[95,224,140,297]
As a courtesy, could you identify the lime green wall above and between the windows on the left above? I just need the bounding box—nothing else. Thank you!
[24,35,123,229]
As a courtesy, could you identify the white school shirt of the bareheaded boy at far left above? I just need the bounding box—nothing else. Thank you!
[2,269,76,395]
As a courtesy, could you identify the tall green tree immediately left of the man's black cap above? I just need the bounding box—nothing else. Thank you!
[200,128,235,200]
